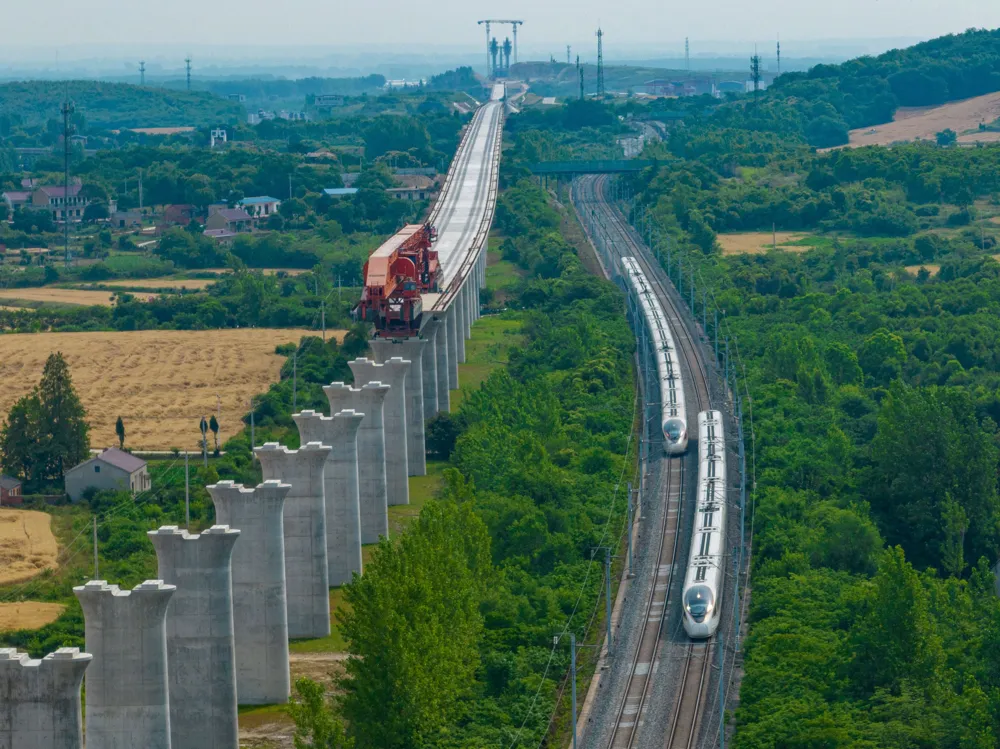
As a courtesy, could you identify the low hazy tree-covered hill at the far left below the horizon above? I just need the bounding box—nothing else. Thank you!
[0,81,245,129]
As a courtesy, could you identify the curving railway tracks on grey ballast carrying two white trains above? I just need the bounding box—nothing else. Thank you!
[581,176,714,749]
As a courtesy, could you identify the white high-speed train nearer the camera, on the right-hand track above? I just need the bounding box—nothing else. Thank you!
[682,411,726,639]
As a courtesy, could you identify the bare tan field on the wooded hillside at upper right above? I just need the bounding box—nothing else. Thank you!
[848,93,1000,148]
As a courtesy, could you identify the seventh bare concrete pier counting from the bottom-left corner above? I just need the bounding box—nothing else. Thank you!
[323,382,390,548]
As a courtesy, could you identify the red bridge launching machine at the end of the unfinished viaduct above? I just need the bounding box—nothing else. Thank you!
[354,224,440,337]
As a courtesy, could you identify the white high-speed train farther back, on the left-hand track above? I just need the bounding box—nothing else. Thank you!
[622,257,688,455]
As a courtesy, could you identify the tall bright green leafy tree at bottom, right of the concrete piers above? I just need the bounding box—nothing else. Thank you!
[341,501,493,749]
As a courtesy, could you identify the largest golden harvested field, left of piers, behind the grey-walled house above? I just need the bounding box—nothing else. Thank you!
[0,328,343,450]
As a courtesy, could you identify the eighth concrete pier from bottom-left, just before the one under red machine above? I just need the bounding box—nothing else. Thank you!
[348,358,410,502]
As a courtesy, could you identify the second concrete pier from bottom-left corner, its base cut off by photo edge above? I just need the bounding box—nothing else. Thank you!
[73,580,177,749]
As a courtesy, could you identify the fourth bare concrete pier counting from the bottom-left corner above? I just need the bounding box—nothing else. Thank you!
[206,481,291,705]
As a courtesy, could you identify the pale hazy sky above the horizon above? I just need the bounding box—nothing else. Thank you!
[0,0,1000,59]
